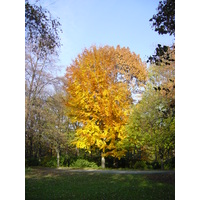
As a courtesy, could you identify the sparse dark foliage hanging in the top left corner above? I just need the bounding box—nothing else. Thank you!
[25,0,62,56]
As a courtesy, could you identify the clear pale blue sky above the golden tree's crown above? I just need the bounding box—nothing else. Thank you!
[35,0,174,74]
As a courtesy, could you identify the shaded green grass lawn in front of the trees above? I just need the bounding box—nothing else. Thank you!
[25,168,175,200]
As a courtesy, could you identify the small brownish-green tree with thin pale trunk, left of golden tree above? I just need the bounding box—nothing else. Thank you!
[44,88,74,167]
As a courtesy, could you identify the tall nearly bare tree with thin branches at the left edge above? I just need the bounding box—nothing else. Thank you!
[25,44,58,158]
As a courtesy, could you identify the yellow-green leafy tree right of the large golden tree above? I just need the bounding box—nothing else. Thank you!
[124,85,175,169]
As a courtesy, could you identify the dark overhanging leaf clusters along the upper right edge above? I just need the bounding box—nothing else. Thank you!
[147,0,175,116]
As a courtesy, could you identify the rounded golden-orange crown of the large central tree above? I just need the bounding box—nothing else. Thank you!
[65,46,147,167]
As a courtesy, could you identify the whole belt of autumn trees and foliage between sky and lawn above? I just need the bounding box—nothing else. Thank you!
[25,0,175,169]
